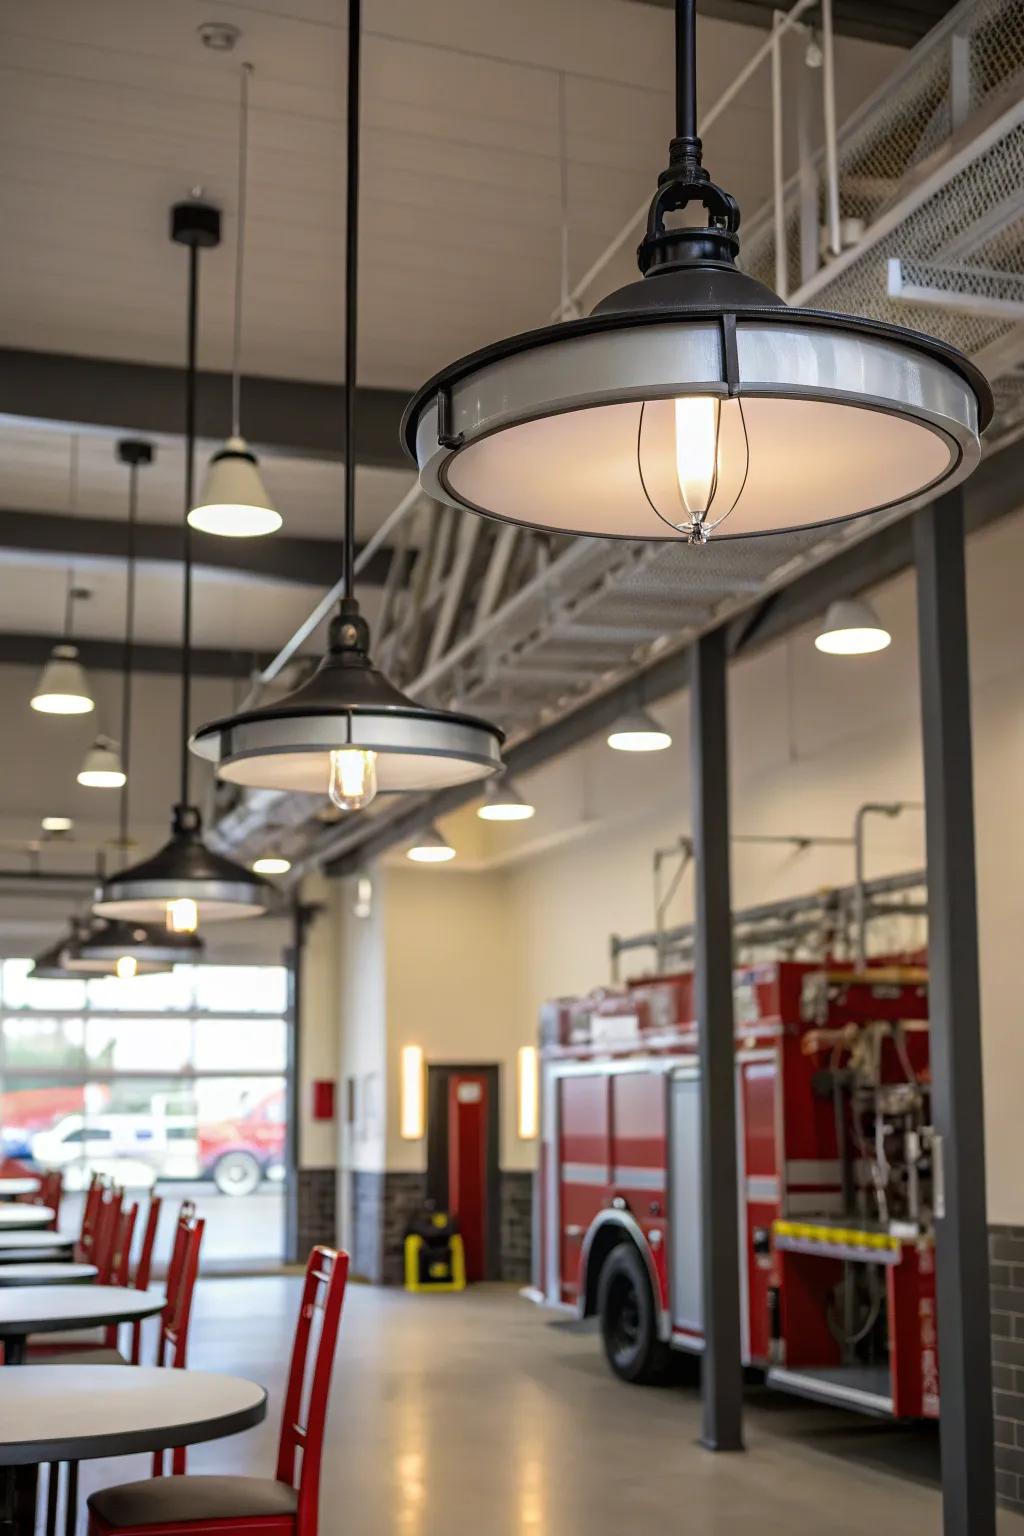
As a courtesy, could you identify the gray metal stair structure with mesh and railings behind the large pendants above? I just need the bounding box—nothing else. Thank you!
[215,0,1024,871]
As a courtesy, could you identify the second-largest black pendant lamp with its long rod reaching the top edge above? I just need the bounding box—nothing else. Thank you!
[192,0,504,811]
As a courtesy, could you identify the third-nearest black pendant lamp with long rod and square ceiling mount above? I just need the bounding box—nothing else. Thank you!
[94,203,270,934]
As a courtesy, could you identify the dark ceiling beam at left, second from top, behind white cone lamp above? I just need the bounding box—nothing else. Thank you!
[0,508,391,590]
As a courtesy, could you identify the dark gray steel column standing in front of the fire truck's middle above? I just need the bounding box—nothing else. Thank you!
[689,628,743,1450]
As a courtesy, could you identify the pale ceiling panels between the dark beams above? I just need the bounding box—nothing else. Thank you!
[0,0,895,942]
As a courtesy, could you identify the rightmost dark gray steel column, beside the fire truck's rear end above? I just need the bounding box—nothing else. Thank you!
[913,490,995,1536]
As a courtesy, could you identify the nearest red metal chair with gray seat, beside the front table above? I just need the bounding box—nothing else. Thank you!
[89,1247,348,1536]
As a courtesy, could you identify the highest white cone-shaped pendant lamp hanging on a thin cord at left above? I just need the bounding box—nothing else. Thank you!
[189,65,282,539]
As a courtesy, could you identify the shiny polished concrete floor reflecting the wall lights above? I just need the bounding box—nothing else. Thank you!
[81,1278,1024,1536]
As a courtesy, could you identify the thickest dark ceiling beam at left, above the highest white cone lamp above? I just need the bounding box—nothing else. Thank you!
[0,347,413,476]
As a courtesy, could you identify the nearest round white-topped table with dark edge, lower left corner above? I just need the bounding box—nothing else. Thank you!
[0,1366,267,1530]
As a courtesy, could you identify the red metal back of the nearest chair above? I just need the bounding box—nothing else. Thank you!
[276,1247,348,1536]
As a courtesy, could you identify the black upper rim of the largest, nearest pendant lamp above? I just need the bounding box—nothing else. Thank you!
[399,293,995,451]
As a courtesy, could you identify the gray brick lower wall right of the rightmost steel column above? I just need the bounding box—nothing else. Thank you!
[989,1227,1024,1510]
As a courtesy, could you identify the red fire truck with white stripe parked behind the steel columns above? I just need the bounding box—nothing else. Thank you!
[534,962,938,1418]
